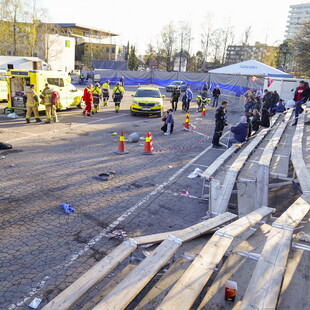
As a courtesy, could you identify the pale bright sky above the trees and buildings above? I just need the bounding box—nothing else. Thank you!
[38,0,310,54]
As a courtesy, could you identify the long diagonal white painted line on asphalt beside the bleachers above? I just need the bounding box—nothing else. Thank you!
[8,132,229,310]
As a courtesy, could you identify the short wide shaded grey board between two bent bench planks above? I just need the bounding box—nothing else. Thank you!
[237,182,256,217]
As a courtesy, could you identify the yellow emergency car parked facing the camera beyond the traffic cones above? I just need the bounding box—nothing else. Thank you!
[130,87,165,116]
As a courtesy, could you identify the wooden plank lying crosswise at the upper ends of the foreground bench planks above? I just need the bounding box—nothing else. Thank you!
[134,212,237,245]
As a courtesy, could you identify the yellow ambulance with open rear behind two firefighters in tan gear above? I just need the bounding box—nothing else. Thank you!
[6,70,83,111]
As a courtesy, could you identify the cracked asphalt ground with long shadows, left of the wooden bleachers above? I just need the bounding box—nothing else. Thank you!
[0,88,239,310]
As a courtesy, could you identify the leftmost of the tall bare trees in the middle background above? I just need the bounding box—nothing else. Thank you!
[161,22,177,71]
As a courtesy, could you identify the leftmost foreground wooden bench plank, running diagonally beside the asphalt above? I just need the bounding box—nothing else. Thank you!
[43,241,137,310]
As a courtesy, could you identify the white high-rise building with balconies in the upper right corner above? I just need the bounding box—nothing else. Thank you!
[285,3,310,39]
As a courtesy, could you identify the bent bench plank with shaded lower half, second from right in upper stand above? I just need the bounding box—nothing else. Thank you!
[256,109,293,208]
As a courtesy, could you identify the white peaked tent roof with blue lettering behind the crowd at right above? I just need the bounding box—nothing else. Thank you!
[209,60,293,77]
